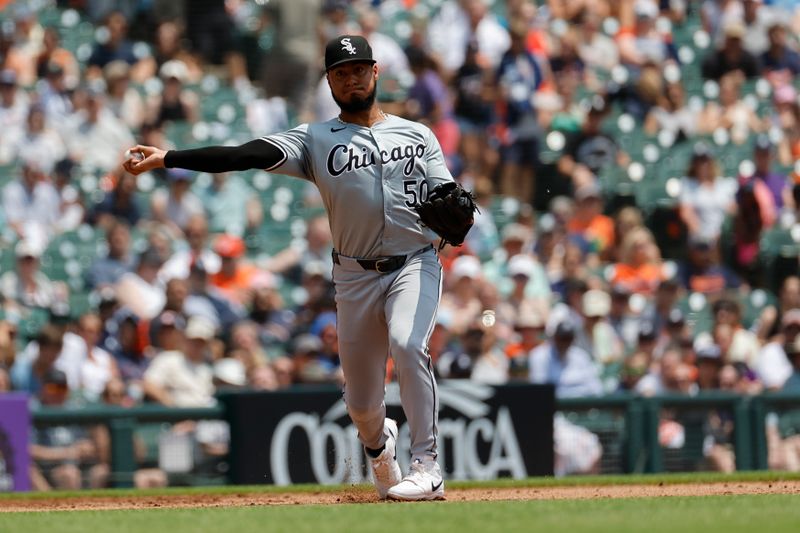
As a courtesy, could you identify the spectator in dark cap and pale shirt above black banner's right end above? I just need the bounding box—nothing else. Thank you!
[529,320,603,398]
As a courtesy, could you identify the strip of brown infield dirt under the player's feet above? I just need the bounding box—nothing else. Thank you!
[0,481,800,512]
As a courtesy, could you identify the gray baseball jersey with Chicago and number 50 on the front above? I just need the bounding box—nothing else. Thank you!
[262,115,453,257]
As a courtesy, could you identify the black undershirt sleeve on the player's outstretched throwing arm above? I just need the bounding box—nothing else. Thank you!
[164,139,285,173]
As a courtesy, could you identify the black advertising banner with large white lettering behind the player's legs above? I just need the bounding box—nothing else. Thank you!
[220,381,555,485]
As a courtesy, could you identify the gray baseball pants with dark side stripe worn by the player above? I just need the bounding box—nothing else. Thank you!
[333,245,442,458]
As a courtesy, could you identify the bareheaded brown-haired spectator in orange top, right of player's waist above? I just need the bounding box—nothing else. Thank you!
[612,227,662,294]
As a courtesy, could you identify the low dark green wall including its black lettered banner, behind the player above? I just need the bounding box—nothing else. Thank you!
[6,382,800,488]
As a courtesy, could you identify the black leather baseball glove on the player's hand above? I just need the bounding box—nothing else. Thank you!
[414,181,478,250]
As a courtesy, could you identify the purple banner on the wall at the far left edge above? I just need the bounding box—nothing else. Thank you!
[0,394,31,492]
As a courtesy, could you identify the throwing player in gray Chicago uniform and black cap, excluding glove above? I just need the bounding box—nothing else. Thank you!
[124,35,453,500]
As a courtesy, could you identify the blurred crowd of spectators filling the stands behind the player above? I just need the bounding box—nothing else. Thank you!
[0,0,800,486]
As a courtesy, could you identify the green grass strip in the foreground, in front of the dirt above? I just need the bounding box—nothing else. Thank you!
[0,495,800,533]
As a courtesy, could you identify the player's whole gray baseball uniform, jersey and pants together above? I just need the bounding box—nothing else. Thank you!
[263,115,453,458]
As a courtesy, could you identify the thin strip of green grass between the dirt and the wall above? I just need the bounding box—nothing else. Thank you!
[0,471,800,498]
